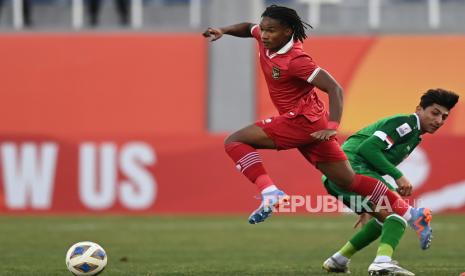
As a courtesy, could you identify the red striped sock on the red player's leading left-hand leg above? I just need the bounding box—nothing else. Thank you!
[224,142,273,191]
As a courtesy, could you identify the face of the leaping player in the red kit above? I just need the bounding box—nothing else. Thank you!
[260,17,292,51]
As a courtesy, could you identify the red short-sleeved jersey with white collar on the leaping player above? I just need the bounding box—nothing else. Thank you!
[251,25,326,122]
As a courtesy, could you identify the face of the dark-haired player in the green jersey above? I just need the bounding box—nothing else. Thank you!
[417,104,449,134]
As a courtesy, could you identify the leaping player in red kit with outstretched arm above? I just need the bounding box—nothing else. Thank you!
[203,5,430,231]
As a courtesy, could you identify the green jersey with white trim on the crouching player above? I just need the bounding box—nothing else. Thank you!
[342,114,421,179]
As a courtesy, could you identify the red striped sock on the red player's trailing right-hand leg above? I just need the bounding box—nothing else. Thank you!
[349,174,410,216]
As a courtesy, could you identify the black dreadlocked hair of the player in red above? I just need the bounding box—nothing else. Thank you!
[262,5,313,42]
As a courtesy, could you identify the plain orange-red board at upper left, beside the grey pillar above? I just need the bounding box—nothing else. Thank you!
[0,34,207,137]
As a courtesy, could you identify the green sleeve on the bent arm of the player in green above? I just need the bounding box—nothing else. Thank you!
[357,135,403,180]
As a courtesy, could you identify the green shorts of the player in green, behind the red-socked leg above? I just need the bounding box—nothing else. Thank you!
[322,170,396,214]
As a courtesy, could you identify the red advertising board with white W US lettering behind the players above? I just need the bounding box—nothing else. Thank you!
[0,135,465,214]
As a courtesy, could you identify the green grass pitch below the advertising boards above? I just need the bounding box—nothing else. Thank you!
[0,215,465,276]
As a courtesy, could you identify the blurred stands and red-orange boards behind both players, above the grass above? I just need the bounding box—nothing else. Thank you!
[0,0,465,214]
